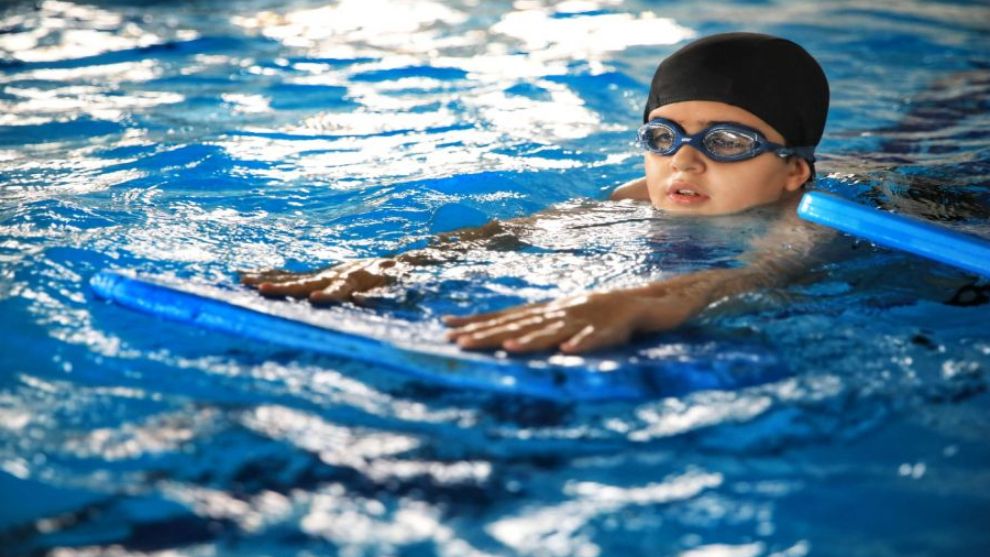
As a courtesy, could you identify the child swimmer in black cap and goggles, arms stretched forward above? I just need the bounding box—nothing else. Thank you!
[241,33,829,353]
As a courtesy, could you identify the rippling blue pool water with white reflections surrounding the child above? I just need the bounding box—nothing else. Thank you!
[0,0,990,557]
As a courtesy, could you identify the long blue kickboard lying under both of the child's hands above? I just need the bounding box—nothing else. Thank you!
[90,271,789,401]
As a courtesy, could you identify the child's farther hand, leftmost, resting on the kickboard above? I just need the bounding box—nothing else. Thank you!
[238,259,401,304]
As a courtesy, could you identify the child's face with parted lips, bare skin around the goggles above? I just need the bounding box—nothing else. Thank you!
[646,101,811,215]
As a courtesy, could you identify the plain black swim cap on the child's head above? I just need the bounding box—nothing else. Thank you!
[643,33,828,153]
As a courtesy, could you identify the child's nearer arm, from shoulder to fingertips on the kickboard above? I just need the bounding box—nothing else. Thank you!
[446,200,826,353]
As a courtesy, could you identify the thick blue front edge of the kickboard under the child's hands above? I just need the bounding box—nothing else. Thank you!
[90,271,788,401]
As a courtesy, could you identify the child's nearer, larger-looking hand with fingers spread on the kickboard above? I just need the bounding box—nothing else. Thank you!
[444,289,705,353]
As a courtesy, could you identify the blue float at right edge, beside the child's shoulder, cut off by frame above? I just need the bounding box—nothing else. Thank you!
[798,192,990,277]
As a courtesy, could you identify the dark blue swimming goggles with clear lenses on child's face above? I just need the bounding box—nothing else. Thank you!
[638,118,815,162]
